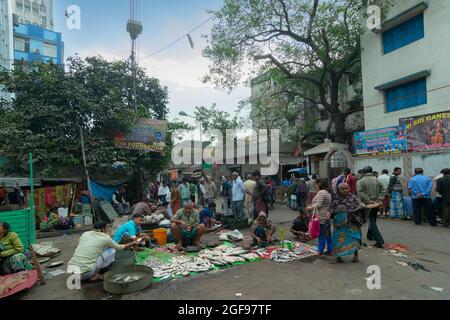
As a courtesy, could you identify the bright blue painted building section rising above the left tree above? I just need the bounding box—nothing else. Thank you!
[14,24,64,65]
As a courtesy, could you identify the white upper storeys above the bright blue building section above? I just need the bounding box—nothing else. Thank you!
[13,0,54,30]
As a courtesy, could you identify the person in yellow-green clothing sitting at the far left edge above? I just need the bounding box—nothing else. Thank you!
[0,222,33,276]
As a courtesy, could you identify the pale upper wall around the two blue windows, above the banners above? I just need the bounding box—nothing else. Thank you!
[361,0,450,130]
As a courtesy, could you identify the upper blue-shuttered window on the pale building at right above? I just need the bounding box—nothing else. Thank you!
[383,13,425,54]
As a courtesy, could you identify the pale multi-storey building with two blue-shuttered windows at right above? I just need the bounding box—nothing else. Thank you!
[356,0,450,176]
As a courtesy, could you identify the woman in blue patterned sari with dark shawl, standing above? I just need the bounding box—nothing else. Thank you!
[331,183,368,263]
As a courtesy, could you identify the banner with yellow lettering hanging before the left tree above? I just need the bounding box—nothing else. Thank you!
[114,118,167,153]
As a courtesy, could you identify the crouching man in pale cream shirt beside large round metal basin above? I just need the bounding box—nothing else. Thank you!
[67,222,137,282]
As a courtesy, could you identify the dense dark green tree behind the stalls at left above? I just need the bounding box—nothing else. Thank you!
[0,57,178,200]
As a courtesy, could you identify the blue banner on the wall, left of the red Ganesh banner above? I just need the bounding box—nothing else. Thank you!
[354,126,407,156]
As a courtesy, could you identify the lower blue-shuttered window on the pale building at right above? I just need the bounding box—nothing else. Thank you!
[386,78,427,112]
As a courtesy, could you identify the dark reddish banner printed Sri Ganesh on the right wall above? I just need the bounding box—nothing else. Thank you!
[400,111,450,151]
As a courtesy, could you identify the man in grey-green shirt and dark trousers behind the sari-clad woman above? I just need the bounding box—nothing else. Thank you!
[356,166,386,249]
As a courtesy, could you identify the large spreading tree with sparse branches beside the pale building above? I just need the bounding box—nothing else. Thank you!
[204,0,389,142]
